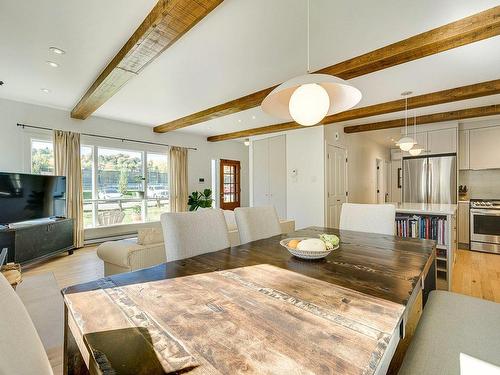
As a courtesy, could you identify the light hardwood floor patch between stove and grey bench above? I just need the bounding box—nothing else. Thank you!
[451,250,500,302]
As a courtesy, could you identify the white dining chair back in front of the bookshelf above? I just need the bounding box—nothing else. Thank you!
[340,203,396,236]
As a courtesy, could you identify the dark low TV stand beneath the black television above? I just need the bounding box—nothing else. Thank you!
[0,218,73,265]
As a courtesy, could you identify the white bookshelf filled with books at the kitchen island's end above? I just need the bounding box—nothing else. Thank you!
[396,205,457,290]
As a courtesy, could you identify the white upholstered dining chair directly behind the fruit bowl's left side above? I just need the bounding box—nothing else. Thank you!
[234,206,281,244]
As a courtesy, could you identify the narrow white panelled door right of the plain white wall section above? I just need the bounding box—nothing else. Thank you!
[326,145,347,228]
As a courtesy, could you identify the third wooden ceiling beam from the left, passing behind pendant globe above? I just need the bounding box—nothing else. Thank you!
[207,79,500,142]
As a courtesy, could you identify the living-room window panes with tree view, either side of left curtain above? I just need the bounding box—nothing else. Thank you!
[31,140,170,228]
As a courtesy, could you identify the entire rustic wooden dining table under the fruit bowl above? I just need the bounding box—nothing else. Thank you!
[62,227,436,374]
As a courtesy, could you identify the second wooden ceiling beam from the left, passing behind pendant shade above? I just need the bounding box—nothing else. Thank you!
[154,6,500,133]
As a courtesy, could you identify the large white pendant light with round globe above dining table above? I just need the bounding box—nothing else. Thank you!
[261,0,361,126]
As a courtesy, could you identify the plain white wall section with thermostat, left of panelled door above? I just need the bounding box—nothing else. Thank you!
[286,126,325,228]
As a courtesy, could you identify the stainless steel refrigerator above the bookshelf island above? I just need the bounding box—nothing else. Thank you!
[403,154,457,204]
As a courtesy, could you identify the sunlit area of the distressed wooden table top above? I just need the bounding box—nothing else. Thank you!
[66,265,404,374]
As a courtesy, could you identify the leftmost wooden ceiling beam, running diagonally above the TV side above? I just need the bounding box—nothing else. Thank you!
[71,0,223,120]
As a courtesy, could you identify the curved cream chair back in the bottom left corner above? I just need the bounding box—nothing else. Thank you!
[0,273,53,375]
